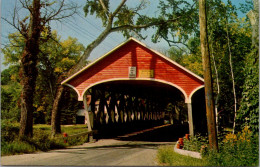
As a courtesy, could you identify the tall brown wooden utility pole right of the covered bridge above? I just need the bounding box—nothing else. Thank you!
[199,0,218,150]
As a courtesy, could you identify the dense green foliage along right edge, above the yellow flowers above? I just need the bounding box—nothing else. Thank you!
[236,48,259,133]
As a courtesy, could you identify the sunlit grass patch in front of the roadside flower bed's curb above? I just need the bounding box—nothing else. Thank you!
[157,145,206,166]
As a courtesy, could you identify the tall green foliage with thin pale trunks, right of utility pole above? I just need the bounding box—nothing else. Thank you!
[207,0,251,128]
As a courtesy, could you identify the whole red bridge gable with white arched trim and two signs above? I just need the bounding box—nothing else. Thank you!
[62,38,204,101]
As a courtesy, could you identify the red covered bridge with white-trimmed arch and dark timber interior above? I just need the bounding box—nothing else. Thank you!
[62,38,204,138]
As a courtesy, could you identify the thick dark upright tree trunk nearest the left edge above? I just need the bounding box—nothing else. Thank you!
[19,0,42,139]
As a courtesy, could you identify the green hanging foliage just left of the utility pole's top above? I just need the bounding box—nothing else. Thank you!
[152,0,199,46]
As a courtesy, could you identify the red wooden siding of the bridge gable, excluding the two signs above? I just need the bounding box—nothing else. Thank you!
[67,40,204,101]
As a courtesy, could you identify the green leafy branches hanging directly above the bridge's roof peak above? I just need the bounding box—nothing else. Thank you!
[83,0,150,38]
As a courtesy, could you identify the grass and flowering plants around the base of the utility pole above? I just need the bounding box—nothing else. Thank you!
[157,126,259,166]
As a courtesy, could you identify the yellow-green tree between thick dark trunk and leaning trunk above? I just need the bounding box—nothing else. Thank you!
[36,31,85,127]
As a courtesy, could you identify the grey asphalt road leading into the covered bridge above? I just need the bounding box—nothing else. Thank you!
[1,123,188,166]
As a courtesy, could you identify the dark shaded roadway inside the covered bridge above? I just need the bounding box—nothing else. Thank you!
[94,122,189,142]
